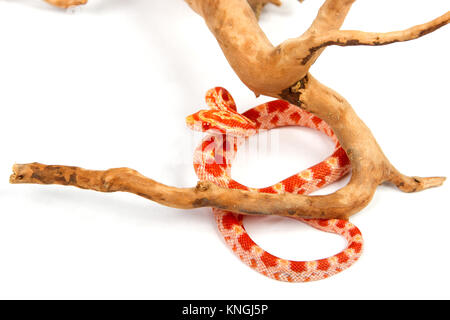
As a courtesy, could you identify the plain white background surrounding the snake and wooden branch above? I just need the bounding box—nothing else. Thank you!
[0,0,450,299]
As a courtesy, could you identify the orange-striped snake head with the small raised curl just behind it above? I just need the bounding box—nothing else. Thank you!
[186,87,256,137]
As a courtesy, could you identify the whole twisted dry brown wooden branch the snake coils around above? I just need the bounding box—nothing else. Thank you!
[14,0,450,219]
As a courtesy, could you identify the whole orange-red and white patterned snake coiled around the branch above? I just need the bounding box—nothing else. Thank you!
[186,87,363,282]
